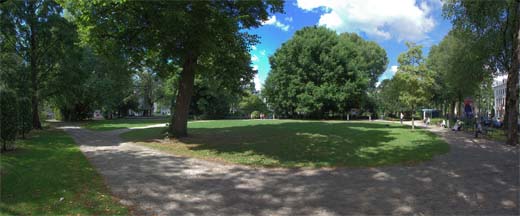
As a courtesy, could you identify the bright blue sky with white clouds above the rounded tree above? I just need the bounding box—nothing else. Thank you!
[248,0,451,89]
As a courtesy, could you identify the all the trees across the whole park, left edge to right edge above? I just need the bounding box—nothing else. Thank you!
[0,0,520,144]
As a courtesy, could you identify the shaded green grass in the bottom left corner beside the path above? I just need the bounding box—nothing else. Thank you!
[0,130,129,215]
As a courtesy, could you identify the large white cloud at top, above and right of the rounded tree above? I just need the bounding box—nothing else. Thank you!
[297,0,441,41]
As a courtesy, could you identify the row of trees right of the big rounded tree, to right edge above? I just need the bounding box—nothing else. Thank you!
[378,0,520,145]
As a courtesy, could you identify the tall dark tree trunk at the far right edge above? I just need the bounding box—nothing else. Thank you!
[506,1,520,145]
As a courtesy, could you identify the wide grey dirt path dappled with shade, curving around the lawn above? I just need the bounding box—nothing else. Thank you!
[60,122,520,215]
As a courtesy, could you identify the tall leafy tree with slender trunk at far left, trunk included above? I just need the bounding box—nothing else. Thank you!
[0,0,76,128]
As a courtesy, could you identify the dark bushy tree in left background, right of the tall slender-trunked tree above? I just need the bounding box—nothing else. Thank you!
[49,46,137,121]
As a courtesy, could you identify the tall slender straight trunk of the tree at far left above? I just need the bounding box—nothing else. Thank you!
[29,4,42,129]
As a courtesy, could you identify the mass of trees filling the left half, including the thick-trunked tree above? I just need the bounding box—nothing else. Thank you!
[0,0,283,150]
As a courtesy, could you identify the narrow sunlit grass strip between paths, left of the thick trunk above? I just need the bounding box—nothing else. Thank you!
[83,118,168,131]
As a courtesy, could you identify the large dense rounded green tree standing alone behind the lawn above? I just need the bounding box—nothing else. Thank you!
[263,27,387,118]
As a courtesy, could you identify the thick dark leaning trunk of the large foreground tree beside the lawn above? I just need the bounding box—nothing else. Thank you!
[170,53,198,137]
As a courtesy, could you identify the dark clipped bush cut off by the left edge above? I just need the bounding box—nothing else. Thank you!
[0,87,18,151]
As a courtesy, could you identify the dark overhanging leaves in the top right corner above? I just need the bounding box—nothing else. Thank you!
[443,0,520,72]
